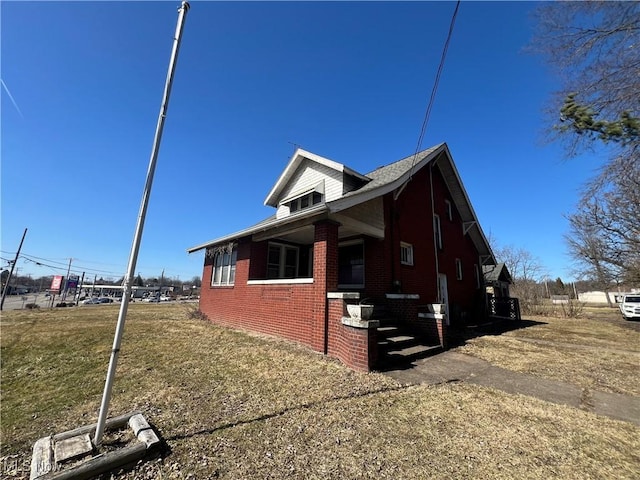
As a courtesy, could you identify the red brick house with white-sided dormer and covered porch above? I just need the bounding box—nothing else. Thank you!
[188,143,496,370]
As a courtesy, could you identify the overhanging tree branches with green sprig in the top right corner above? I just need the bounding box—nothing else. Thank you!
[531,1,640,153]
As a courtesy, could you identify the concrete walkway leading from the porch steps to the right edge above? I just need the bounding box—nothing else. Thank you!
[385,351,640,425]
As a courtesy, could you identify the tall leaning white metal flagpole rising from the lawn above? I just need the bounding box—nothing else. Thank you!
[93,1,189,446]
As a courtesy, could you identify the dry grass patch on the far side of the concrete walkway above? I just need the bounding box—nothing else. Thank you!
[460,316,640,396]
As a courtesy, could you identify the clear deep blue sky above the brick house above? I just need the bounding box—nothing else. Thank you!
[0,1,602,280]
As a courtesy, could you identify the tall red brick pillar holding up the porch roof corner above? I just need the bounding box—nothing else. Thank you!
[313,220,339,354]
